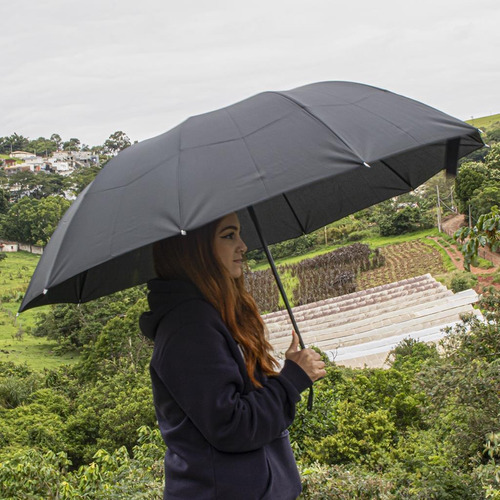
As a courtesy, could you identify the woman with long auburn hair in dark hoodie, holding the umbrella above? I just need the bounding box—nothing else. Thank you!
[140,213,325,500]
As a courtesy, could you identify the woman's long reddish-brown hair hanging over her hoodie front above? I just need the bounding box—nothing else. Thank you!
[153,219,278,387]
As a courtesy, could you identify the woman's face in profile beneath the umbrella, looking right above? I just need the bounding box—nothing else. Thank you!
[214,213,247,278]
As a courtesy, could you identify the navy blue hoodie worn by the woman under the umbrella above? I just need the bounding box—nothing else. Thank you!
[140,279,312,500]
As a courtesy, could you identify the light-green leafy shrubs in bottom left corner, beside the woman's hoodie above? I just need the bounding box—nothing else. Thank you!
[0,426,165,500]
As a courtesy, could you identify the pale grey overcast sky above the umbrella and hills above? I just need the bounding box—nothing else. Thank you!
[0,0,500,146]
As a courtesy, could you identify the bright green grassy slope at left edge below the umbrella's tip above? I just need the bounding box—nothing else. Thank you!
[0,252,77,370]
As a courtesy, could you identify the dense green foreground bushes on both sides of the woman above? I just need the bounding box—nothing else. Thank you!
[0,290,500,500]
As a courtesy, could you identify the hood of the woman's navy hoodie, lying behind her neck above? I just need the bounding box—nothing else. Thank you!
[139,278,203,340]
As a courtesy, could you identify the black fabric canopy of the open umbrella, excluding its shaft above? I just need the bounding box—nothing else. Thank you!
[20,82,483,311]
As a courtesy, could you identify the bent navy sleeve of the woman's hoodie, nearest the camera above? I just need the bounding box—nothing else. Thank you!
[152,308,312,452]
